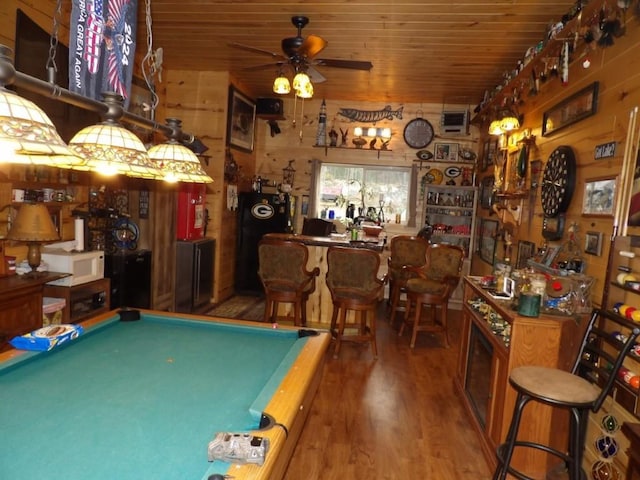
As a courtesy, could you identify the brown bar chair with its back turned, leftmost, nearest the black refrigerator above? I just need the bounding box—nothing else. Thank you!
[258,238,320,325]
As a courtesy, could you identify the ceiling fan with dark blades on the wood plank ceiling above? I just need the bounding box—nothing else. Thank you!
[229,15,373,83]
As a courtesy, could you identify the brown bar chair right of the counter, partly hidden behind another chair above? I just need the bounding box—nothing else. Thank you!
[387,235,429,323]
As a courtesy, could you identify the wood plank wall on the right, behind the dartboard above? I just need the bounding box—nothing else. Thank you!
[472,16,640,310]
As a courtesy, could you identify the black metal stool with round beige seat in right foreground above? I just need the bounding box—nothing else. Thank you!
[493,309,640,480]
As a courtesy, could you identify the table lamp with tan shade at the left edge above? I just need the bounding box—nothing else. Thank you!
[7,203,60,276]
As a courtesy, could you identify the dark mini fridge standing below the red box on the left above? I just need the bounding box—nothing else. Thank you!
[175,238,216,313]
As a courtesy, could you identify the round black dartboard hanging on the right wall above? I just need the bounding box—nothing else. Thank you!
[541,146,576,217]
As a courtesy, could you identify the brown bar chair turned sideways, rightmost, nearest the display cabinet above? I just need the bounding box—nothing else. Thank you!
[398,243,464,348]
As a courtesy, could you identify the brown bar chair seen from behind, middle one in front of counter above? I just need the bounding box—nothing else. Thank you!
[327,247,387,358]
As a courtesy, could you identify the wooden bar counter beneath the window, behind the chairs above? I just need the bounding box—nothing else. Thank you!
[264,233,387,327]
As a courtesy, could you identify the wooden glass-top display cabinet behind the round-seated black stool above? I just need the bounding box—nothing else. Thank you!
[454,277,587,478]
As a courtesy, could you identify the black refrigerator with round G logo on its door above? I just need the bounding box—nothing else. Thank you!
[235,192,294,295]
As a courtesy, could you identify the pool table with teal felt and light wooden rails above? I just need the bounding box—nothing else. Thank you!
[0,310,330,480]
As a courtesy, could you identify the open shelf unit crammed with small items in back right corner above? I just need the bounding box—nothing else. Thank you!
[422,174,478,308]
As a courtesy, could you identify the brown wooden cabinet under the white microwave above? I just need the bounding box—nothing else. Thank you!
[43,278,111,323]
